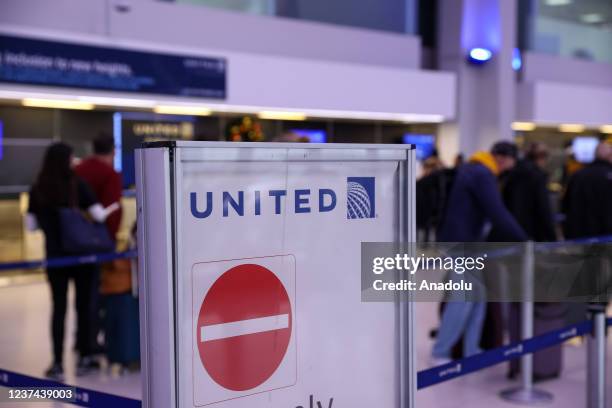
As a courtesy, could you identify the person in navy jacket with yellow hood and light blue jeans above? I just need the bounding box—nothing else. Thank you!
[432,142,527,365]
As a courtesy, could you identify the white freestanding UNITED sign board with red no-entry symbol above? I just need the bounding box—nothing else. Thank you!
[136,141,414,408]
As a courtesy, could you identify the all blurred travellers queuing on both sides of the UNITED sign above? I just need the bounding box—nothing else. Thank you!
[23,134,612,380]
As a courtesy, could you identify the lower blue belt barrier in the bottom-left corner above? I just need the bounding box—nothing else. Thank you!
[0,368,142,408]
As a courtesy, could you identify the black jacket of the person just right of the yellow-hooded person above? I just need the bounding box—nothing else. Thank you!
[489,160,556,242]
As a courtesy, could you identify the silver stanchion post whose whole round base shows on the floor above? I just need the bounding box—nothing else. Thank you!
[500,241,553,404]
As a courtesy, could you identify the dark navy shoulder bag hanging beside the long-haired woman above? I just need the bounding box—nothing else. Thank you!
[59,207,115,255]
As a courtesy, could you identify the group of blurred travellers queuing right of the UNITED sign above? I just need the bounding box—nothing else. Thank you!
[416,139,612,380]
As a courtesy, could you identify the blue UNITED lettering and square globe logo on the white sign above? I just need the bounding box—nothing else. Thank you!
[189,177,376,220]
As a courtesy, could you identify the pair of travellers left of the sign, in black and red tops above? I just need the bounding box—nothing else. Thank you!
[27,134,139,380]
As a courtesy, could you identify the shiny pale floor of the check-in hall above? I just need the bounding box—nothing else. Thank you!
[0,282,612,408]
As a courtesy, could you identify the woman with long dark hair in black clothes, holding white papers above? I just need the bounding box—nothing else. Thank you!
[28,143,113,379]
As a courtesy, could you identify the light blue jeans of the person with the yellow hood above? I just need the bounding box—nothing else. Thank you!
[432,274,486,358]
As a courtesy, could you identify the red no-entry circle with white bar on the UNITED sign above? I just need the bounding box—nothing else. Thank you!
[196,264,292,391]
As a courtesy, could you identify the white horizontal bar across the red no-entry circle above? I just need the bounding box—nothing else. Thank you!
[200,314,289,342]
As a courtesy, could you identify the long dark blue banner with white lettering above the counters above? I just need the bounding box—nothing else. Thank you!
[0,35,227,99]
